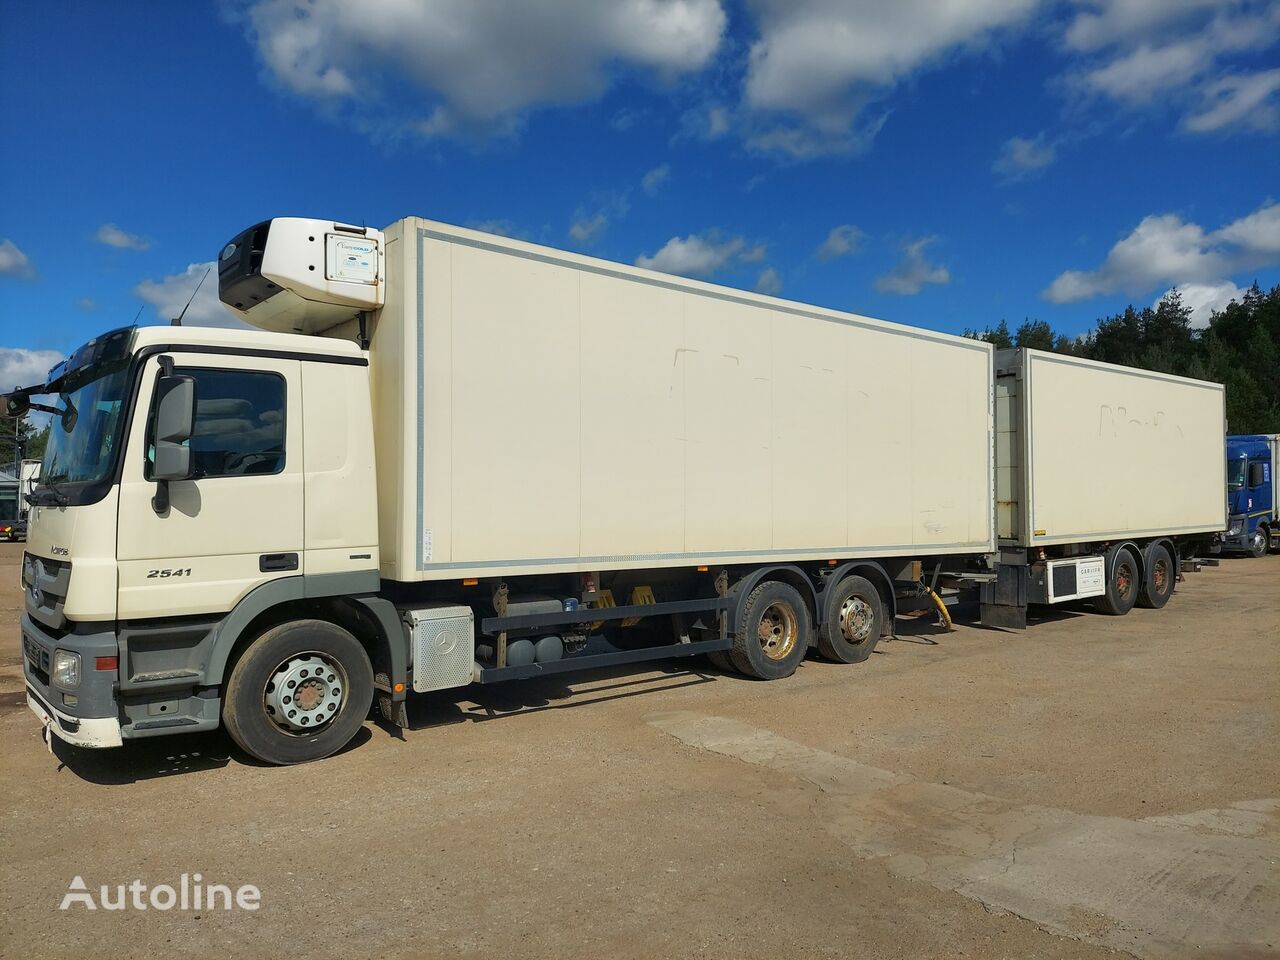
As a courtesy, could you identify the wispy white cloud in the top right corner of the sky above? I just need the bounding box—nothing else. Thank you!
[1064,0,1280,133]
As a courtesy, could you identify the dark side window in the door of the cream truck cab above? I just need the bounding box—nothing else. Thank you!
[148,367,284,480]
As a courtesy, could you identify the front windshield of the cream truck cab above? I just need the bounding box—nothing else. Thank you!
[40,361,128,485]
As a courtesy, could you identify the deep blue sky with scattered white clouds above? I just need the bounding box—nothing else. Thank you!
[0,0,1280,389]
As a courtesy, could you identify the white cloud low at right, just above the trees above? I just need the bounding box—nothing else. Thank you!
[1041,202,1280,303]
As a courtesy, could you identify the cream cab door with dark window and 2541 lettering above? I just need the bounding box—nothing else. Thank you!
[116,351,303,620]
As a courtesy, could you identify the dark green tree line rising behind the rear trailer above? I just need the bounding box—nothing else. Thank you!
[964,283,1280,434]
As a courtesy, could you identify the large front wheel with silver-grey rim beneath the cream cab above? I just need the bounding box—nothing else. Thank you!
[223,620,374,765]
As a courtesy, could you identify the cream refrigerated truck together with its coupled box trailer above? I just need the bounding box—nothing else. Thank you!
[8,218,1225,763]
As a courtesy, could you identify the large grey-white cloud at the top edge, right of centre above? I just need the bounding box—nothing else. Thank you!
[744,0,1038,157]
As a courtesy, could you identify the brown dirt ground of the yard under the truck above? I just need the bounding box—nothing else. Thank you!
[0,545,1280,960]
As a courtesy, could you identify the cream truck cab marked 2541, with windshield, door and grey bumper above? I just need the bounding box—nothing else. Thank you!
[9,326,379,746]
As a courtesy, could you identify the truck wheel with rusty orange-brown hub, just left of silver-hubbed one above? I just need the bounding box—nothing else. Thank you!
[730,580,813,680]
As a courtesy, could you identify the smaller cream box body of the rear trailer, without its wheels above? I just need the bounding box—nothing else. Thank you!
[996,349,1226,547]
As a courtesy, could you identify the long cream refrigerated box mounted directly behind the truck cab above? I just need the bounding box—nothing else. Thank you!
[348,218,995,581]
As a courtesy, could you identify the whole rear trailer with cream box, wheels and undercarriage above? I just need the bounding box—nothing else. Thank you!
[982,349,1226,627]
